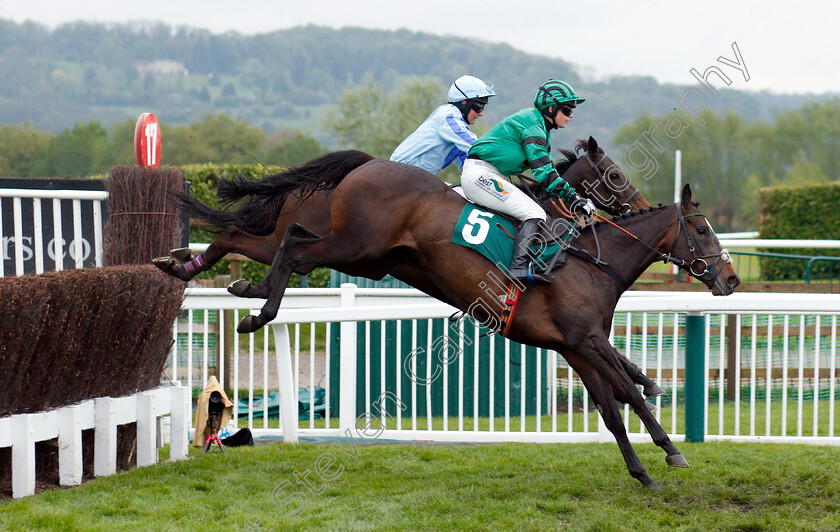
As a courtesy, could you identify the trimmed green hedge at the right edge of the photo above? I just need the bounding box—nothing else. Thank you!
[758,182,840,281]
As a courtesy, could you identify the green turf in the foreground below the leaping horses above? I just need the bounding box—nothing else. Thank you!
[0,439,840,531]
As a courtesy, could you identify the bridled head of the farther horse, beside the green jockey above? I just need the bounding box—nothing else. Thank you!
[554,137,650,215]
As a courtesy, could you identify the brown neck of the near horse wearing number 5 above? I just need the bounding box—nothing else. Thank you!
[579,205,678,292]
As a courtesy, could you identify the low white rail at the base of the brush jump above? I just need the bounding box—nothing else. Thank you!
[0,386,192,498]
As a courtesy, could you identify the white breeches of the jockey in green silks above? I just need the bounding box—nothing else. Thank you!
[461,159,545,221]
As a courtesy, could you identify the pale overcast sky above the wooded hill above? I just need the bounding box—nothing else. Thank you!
[0,0,840,93]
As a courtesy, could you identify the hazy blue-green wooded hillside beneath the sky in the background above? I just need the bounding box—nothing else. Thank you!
[0,19,821,150]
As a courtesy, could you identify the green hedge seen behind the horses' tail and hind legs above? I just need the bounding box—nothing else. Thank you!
[178,164,330,287]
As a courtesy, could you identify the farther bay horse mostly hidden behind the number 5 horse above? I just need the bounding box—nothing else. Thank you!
[161,136,665,394]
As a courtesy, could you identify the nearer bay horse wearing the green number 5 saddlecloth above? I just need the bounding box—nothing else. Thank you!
[156,144,740,487]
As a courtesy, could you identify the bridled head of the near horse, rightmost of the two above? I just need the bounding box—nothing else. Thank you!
[668,184,741,296]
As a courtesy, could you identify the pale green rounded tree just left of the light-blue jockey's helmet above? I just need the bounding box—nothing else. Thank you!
[325,77,446,159]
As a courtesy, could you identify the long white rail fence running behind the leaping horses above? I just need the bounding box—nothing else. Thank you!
[174,285,840,445]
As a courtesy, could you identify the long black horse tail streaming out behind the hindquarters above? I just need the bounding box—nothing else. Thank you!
[182,150,374,236]
